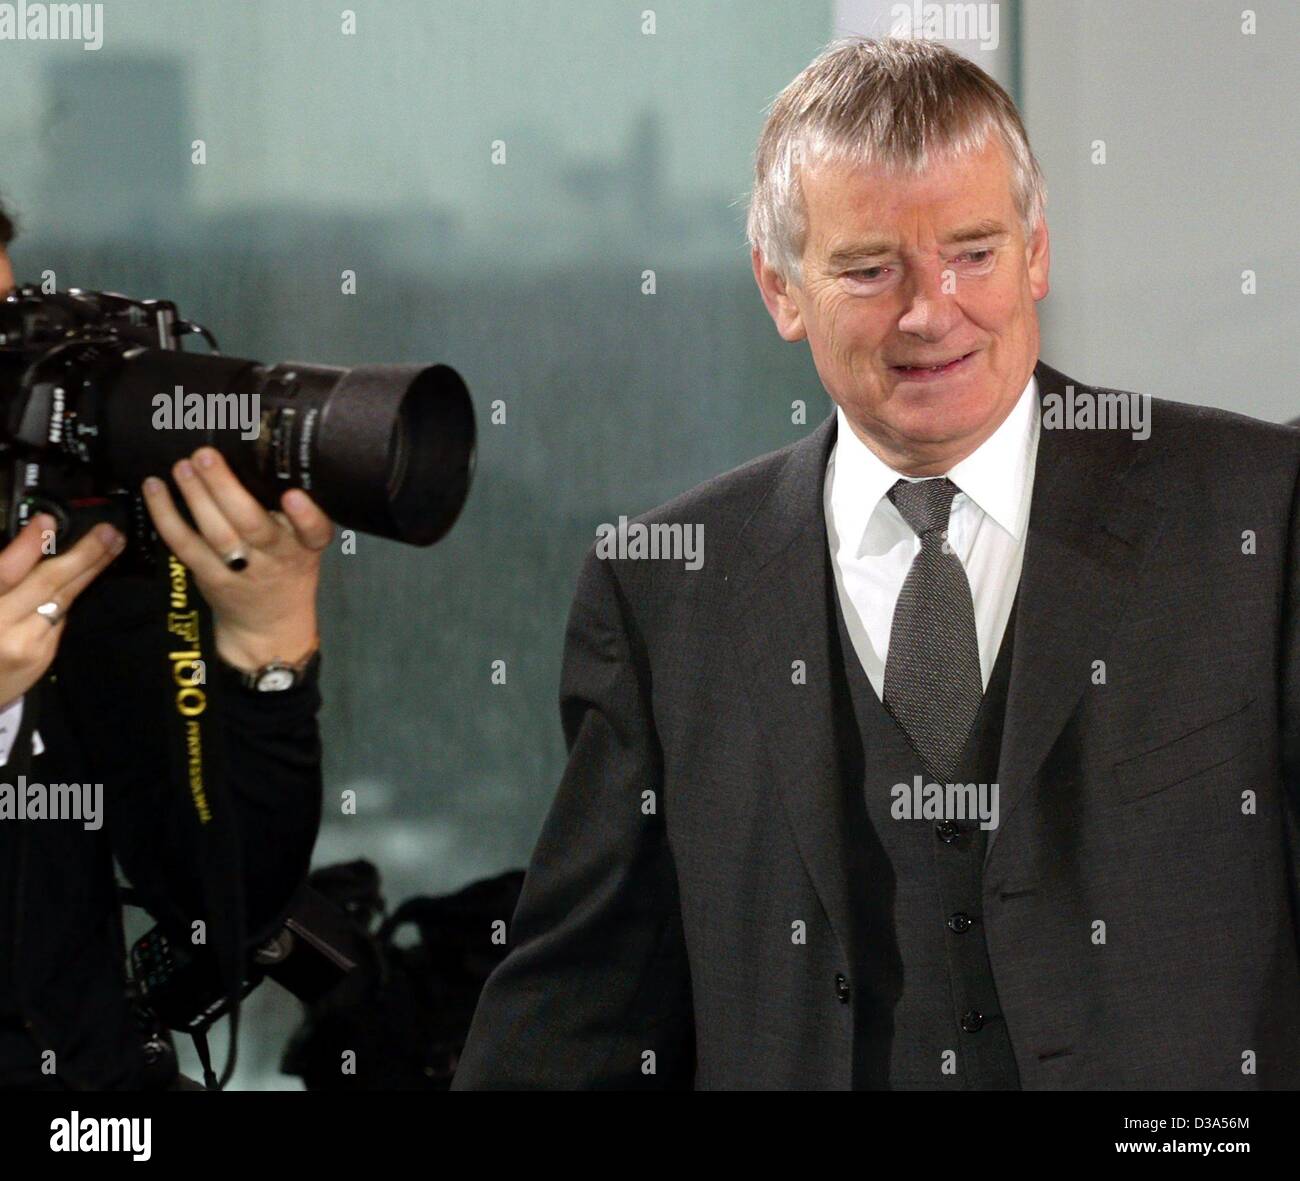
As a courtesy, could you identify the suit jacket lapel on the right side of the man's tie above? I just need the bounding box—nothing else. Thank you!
[985,363,1161,861]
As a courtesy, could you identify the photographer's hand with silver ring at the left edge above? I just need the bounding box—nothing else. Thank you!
[0,512,125,705]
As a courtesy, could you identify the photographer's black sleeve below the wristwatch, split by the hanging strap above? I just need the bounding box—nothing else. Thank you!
[59,580,321,942]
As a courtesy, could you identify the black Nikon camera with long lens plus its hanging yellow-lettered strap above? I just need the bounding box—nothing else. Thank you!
[0,286,475,1089]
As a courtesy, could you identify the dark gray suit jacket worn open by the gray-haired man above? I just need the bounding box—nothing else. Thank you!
[455,364,1300,1089]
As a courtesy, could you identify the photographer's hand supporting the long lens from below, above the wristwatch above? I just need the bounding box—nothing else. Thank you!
[144,447,334,671]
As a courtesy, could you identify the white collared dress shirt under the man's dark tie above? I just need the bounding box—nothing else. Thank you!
[823,376,1040,700]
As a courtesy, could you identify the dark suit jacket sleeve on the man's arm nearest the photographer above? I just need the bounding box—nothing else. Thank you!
[454,551,694,1090]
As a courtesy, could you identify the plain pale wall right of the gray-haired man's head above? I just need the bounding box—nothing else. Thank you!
[1022,0,1300,421]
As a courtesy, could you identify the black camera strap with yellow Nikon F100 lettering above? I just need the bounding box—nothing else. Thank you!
[153,550,247,1090]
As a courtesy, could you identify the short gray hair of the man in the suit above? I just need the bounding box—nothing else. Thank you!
[745,36,1047,284]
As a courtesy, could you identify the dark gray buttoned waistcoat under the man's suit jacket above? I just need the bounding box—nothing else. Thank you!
[829,579,1019,1090]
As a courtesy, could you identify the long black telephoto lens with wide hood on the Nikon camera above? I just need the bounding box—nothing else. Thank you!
[95,349,475,545]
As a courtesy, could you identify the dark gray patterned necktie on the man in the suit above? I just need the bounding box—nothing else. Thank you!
[884,477,984,783]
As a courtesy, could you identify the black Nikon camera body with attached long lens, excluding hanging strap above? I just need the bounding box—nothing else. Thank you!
[0,286,475,568]
